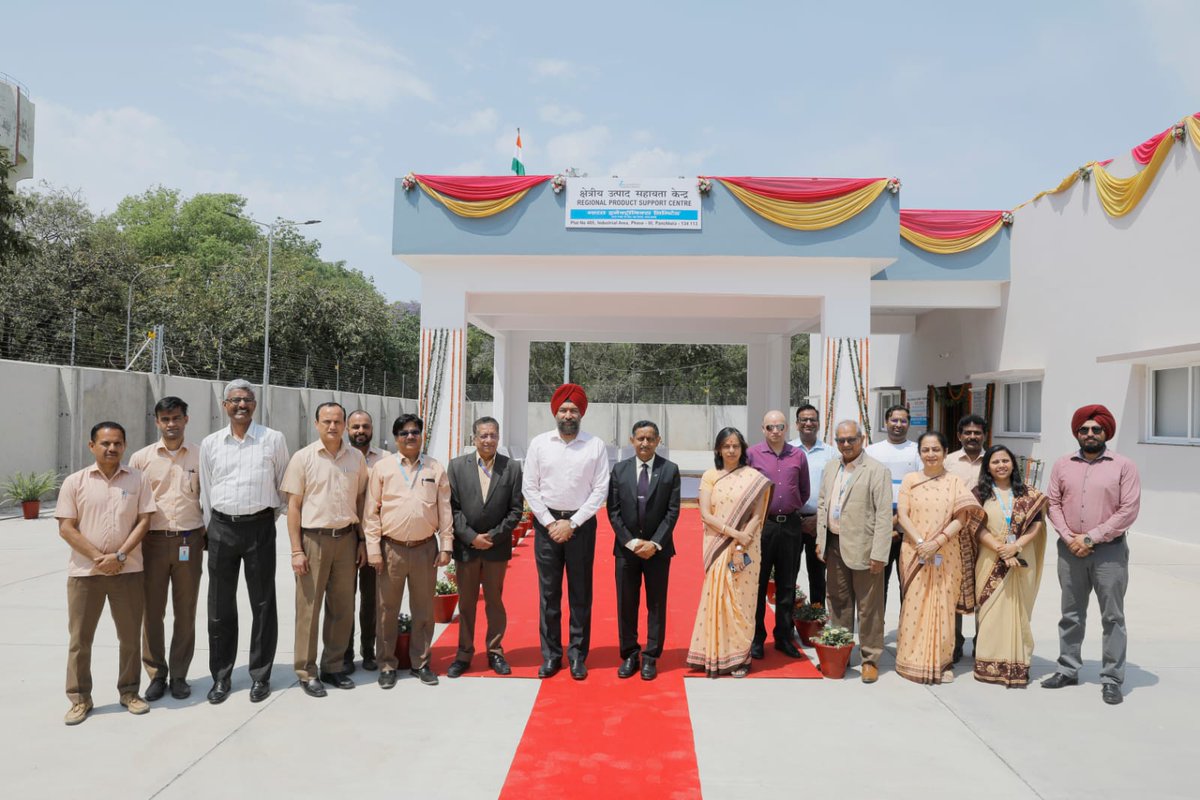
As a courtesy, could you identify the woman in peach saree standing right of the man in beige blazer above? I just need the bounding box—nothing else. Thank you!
[896,432,983,684]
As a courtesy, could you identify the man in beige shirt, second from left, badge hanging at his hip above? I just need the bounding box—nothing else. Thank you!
[130,397,204,703]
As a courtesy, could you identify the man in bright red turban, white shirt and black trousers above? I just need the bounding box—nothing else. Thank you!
[522,384,608,680]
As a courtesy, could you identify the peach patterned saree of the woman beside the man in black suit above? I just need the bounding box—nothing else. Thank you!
[688,467,770,675]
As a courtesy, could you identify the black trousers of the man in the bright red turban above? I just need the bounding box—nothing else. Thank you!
[533,510,596,661]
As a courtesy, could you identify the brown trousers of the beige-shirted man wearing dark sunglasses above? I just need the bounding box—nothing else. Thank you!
[376,536,439,670]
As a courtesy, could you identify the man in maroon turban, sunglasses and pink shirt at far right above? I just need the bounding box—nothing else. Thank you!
[1042,405,1141,705]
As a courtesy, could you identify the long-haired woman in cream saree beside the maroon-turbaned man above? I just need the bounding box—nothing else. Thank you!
[974,445,1049,688]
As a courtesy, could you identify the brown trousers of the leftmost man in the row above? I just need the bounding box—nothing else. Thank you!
[67,572,144,703]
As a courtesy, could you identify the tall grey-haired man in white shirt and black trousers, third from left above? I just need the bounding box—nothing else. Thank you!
[200,378,288,704]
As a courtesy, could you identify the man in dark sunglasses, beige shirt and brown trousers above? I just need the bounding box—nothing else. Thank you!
[364,414,454,688]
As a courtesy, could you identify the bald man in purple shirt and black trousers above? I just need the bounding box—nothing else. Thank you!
[746,411,809,658]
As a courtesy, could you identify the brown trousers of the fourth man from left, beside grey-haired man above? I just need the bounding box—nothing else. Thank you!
[295,528,359,681]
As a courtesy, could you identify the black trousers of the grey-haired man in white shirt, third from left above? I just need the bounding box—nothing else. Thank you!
[208,509,280,681]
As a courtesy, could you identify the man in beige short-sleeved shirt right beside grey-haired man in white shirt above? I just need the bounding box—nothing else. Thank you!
[280,402,367,697]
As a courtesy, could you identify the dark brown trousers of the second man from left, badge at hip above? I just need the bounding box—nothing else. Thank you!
[142,531,204,680]
